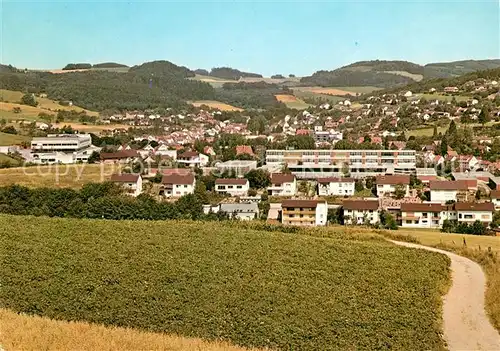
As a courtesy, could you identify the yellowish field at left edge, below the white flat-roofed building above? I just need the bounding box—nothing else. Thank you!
[0,163,119,189]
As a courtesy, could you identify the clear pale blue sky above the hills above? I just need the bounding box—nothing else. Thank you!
[0,0,500,75]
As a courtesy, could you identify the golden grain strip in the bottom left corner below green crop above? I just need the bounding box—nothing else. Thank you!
[0,309,256,351]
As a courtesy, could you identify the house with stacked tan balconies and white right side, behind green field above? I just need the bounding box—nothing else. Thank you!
[281,200,328,226]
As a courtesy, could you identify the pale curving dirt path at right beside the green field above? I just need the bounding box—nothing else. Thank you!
[391,240,500,351]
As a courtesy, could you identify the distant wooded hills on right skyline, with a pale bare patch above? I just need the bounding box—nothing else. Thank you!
[300,60,500,88]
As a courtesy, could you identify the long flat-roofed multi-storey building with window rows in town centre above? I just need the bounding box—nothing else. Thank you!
[266,150,416,179]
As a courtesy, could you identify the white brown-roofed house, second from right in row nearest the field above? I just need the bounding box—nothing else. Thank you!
[401,203,444,228]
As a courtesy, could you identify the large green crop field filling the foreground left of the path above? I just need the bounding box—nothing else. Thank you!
[0,215,449,350]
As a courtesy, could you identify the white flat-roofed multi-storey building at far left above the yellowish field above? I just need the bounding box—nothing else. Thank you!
[31,134,101,164]
